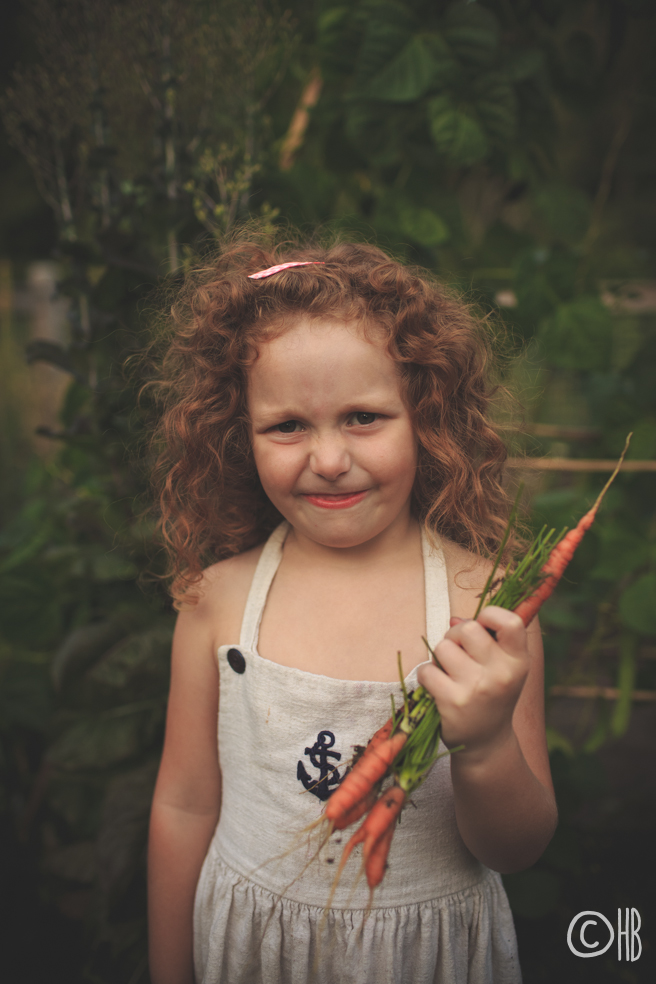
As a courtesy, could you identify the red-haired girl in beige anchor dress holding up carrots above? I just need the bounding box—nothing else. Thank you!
[149,244,556,984]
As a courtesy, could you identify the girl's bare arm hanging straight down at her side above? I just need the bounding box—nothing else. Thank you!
[148,600,221,984]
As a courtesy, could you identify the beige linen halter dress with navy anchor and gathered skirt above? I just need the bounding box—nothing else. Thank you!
[194,524,521,984]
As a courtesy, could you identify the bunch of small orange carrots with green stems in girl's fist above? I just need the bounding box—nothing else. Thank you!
[322,434,631,895]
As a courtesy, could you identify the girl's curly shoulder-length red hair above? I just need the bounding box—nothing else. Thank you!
[154,240,509,595]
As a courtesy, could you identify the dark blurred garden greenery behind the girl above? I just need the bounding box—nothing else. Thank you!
[0,0,656,984]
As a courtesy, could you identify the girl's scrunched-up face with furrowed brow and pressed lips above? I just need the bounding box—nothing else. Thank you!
[248,320,417,548]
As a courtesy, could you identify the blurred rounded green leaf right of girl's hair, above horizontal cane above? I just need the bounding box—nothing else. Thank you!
[540,295,613,371]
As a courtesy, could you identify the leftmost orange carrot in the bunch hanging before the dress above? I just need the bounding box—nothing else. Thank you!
[325,718,408,829]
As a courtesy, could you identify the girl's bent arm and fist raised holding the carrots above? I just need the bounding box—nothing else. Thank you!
[419,606,558,873]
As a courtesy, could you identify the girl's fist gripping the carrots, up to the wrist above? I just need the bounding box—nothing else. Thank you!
[418,605,530,755]
